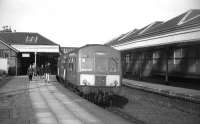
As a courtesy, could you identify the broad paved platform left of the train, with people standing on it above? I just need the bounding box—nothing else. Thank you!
[0,76,129,124]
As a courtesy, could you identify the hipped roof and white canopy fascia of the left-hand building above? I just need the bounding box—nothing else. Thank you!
[0,32,59,53]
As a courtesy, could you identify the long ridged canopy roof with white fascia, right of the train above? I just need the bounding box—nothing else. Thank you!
[106,9,200,51]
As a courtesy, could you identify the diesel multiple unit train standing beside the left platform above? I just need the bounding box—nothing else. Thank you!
[57,44,122,101]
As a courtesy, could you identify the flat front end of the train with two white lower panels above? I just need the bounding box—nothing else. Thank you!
[78,45,122,95]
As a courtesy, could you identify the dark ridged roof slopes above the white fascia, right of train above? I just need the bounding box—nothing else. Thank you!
[107,10,200,45]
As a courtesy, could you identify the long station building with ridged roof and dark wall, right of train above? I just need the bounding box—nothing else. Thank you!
[106,10,200,88]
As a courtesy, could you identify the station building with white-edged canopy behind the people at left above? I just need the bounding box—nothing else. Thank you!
[0,32,59,75]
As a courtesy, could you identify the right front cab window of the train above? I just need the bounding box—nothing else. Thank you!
[108,57,119,72]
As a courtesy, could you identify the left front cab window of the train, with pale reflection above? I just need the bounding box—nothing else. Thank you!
[80,56,93,71]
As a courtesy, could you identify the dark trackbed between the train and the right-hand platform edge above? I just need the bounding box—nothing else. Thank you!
[61,80,200,124]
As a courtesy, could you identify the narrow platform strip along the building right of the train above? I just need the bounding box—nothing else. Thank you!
[123,79,200,103]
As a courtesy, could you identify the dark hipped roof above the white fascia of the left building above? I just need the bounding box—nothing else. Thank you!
[0,32,57,45]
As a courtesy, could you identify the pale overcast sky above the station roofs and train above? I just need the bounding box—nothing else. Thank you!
[0,0,200,47]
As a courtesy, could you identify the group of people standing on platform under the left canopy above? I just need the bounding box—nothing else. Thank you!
[27,64,51,81]
